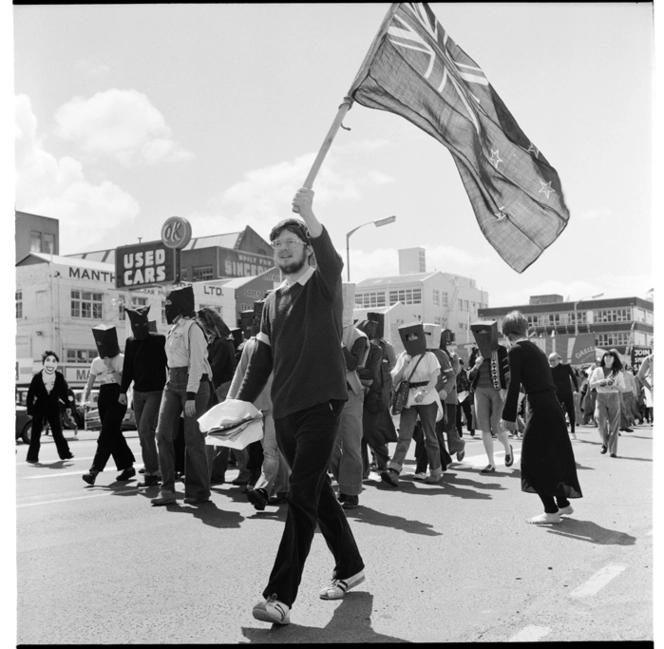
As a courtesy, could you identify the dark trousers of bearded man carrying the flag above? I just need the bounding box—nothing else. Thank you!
[263,400,364,606]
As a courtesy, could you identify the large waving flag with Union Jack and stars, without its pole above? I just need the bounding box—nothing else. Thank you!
[349,3,569,273]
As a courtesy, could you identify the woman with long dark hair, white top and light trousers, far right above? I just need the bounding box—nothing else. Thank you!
[588,352,625,457]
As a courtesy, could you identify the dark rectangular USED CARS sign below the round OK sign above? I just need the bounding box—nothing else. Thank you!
[115,241,177,288]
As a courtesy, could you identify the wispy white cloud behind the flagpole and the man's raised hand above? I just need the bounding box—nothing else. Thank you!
[187,140,393,240]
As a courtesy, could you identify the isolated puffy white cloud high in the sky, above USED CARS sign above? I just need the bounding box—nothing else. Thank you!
[55,88,193,165]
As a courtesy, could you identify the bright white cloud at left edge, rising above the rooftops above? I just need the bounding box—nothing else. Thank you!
[15,95,140,253]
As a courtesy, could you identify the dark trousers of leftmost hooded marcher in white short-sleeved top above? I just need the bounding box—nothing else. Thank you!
[90,383,135,472]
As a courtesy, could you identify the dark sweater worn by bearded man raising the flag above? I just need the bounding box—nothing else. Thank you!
[237,228,348,419]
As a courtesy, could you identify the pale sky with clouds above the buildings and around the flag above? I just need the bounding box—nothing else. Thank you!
[3,3,654,307]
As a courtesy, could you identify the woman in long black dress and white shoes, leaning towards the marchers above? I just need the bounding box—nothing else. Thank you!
[502,311,582,525]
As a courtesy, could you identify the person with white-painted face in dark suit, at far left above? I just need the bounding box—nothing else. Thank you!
[26,351,74,464]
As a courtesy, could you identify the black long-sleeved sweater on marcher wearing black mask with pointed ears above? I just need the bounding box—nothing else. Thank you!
[120,332,167,394]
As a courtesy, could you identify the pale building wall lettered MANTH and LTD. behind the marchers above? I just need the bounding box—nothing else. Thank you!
[16,253,279,387]
